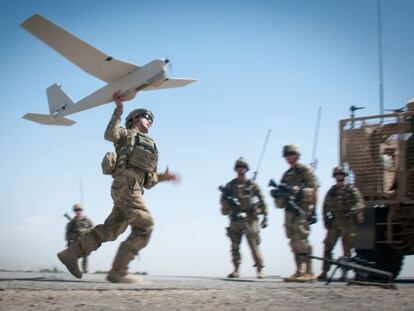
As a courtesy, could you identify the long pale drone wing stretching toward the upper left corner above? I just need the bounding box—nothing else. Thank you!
[21,14,140,82]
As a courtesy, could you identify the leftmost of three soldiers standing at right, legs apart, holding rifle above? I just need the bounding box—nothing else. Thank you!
[221,158,267,279]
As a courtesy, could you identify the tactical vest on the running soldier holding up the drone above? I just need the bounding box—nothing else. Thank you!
[116,131,158,173]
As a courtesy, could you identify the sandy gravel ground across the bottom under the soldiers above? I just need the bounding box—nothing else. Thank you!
[0,272,414,311]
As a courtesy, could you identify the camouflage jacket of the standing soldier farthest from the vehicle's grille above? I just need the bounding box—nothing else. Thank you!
[220,178,267,216]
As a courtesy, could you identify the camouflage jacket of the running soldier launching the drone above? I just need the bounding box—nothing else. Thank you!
[104,108,164,189]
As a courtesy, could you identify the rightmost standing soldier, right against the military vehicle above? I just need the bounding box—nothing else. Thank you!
[318,166,365,281]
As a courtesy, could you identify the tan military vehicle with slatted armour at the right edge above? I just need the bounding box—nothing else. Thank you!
[339,98,414,277]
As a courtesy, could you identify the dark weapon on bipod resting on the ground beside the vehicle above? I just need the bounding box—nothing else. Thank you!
[306,255,394,285]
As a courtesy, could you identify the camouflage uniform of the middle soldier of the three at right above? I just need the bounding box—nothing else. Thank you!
[277,163,319,279]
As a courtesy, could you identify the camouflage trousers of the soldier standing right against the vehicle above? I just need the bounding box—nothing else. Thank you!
[322,217,356,272]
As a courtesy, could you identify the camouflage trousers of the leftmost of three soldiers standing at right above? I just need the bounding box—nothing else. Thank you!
[227,217,264,268]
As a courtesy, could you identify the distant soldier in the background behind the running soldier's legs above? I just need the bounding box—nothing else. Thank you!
[65,203,93,273]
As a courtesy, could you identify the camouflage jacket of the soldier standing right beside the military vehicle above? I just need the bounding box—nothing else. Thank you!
[323,185,365,219]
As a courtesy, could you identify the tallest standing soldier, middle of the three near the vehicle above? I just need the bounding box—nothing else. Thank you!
[275,145,319,282]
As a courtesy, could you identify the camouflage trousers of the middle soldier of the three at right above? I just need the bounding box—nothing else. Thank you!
[285,210,312,255]
